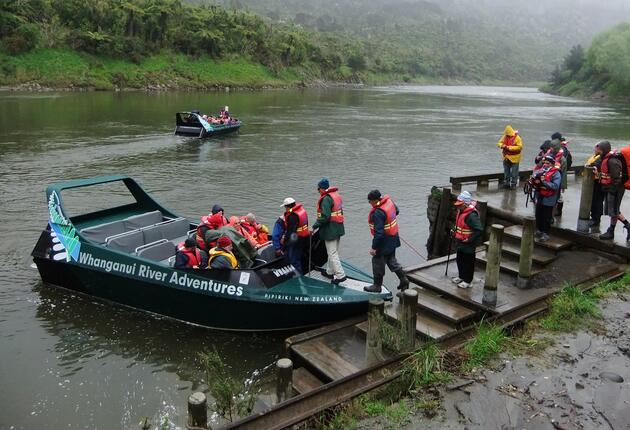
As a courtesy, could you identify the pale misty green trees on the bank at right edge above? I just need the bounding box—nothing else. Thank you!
[543,23,630,99]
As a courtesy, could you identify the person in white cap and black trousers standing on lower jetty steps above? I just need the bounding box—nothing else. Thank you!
[451,191,483,288]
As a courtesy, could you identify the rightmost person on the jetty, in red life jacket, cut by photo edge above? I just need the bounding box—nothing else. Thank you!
[598,140,630,241]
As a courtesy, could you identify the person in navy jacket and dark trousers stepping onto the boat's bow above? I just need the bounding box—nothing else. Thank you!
[363,190,409,293]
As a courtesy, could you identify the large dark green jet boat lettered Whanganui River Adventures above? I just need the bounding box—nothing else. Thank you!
[32,176,392,331]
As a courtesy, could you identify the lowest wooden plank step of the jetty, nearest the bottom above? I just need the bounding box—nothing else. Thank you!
[291,339,359,380]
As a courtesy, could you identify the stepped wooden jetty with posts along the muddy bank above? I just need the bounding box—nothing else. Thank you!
[218,167,630,429]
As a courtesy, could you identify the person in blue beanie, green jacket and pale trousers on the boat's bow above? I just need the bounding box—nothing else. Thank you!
[313,178,348,284]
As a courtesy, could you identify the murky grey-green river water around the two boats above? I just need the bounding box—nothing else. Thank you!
[0,87,630,429]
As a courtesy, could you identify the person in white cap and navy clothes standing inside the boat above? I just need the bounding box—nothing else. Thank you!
[280,197,311,274]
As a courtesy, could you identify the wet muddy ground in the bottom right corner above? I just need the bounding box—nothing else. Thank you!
[358,294,630,430]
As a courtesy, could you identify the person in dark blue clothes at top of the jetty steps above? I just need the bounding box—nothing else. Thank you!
[532,155,562,242]
